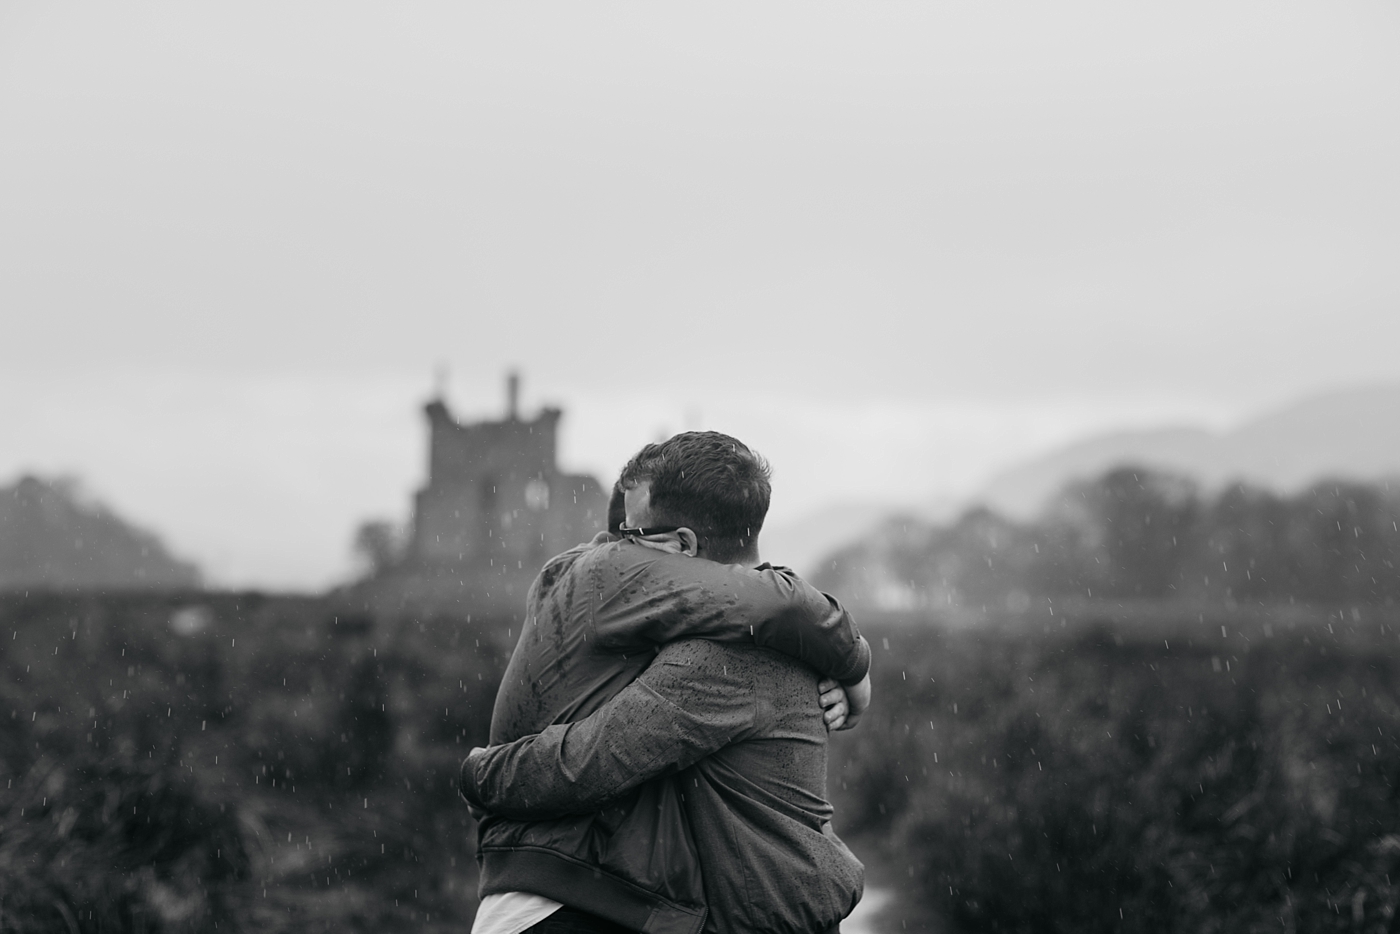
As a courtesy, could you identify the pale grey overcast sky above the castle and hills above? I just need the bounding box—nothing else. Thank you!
[0,1,1400,587]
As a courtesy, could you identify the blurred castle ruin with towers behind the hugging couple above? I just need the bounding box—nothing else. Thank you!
[351,374,608,616]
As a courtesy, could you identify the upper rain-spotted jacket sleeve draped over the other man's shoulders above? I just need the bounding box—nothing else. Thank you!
[592,542,871,685]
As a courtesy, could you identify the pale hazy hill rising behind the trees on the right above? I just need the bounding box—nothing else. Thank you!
[980,384,1400,518]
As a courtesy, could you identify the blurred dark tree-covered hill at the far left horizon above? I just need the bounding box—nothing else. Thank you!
[0,476,200,591]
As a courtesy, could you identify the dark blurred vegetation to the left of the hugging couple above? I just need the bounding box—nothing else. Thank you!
[0,592,512,934]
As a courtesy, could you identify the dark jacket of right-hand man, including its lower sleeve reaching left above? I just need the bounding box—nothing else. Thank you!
[462,640,864,934]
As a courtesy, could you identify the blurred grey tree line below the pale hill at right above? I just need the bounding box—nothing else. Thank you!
[813,466,1400,611]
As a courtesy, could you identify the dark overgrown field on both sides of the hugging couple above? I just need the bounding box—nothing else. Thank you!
[0,592,1400,931]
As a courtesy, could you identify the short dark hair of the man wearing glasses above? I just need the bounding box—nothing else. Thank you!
[617,431,773,562]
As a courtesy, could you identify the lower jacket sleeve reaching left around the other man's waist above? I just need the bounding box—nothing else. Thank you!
[461,640,756,821]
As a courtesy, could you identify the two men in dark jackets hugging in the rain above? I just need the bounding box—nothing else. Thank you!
[461,431,871,934]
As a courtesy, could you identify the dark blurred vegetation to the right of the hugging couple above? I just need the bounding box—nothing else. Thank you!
[830,608,1400,934]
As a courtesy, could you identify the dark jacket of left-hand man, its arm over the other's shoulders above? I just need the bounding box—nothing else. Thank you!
[463,534,869,934]
